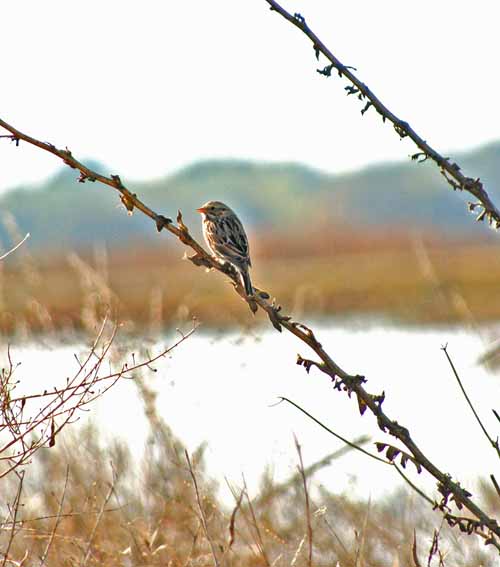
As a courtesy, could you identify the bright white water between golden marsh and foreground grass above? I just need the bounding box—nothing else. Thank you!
[6,322,500,499]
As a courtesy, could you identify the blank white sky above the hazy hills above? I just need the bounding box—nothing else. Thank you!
[0,0,500,194]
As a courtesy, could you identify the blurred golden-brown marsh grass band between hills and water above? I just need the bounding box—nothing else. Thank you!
[0,227,500,334]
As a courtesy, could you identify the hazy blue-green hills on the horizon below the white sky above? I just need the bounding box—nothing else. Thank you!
[0,142,500,250]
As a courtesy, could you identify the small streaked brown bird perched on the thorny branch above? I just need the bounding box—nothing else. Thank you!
[196,201,253,296]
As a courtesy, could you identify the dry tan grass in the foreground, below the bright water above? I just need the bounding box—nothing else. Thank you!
[0,372,498,567]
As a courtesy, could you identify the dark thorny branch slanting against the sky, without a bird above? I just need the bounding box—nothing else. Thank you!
[265,0,500,229]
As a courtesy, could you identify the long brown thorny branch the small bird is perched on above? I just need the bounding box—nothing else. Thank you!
[0,102,500,551]
